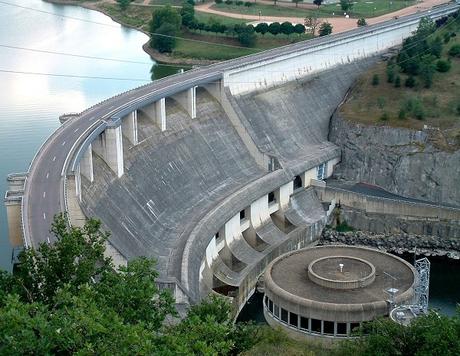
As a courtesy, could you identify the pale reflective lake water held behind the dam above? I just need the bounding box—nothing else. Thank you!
[0,0,183,269]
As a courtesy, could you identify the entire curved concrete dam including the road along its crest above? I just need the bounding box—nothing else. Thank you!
[5,5,458,310]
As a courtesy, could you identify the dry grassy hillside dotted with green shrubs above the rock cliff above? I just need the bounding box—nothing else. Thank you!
[341,13,460,136]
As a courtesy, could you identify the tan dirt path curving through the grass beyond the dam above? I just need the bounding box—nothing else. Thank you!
[195,0,448,33]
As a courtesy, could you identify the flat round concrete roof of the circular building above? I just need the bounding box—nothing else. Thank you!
[265,245,416,320]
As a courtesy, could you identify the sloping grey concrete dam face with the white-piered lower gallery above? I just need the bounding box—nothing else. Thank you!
[81,60,371,308]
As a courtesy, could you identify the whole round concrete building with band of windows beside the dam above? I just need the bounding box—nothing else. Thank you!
[264,245,416,338]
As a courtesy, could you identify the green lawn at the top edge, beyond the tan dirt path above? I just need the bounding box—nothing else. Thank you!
[212,0,415,18]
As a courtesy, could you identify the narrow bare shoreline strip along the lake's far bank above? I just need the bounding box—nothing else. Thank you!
[43,0,219,66]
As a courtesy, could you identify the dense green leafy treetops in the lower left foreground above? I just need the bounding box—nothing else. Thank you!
[0,216,257,355]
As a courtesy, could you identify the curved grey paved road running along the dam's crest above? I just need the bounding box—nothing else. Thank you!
[22,5,458,246]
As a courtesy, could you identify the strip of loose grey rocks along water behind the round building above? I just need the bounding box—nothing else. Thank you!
[320,228,460,260]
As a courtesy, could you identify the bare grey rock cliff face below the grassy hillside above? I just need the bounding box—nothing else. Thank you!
[329,115,460,206]
